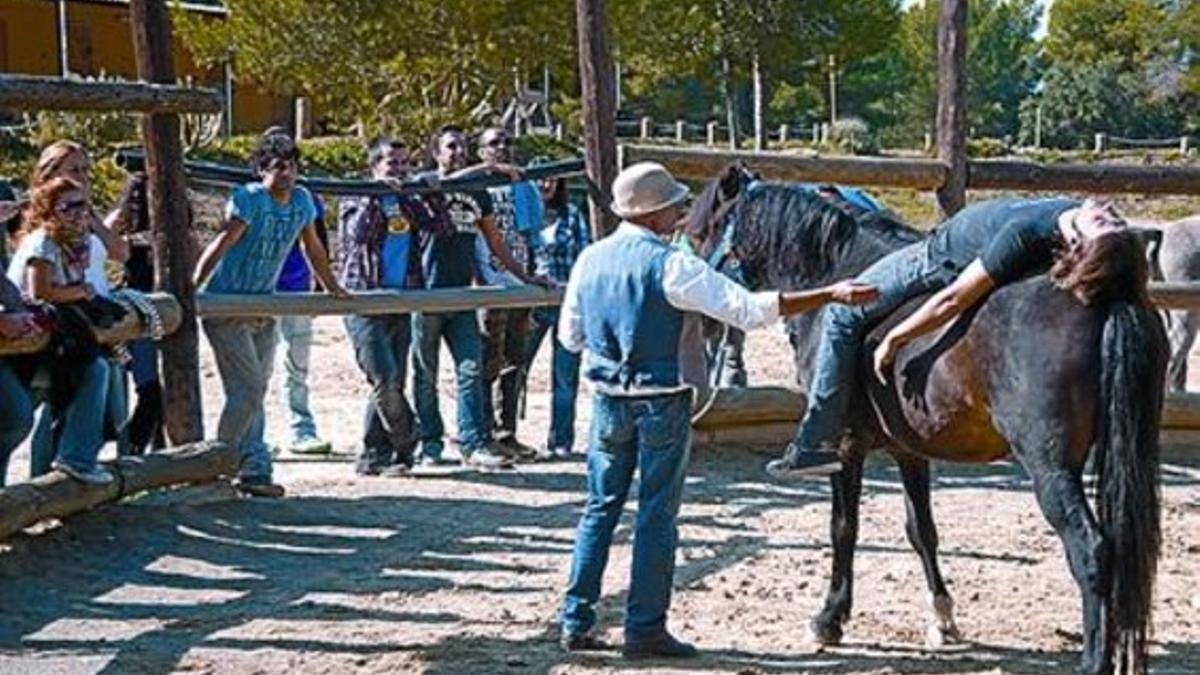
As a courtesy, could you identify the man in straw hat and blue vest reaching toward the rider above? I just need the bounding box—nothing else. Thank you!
[558,162,876,658]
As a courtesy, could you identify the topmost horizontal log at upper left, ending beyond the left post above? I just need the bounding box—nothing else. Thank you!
[0,74,221,113]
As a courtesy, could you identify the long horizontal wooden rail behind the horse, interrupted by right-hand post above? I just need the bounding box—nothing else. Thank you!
[622,144,1200,195]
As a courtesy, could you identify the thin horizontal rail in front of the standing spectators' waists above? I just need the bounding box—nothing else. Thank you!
[196,286,563,318]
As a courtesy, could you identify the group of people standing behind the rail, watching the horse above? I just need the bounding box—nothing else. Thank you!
[194,126,588,496]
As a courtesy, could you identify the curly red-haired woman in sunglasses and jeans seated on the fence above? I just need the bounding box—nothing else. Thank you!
[8,178,113,485]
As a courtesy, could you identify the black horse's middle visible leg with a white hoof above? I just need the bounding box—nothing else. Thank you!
[896,455,960,647]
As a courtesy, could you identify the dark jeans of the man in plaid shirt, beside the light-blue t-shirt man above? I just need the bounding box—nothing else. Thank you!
[346,315,416,471]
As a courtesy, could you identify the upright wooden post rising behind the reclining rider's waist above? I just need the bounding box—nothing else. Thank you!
[937,0,967,219]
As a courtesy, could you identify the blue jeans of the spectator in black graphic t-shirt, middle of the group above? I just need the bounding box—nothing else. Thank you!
[413,311,491,456]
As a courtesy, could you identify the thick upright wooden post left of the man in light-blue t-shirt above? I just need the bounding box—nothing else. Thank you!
[130,0,204,446]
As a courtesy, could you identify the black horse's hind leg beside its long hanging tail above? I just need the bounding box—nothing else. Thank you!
[1030,467,1112,675]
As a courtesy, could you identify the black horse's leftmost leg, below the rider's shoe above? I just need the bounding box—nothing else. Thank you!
[811,448,864,645]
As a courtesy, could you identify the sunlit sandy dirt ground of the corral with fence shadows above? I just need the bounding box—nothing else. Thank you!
[0,318,1200,675]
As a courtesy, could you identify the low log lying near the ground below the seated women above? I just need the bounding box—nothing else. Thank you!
[0,442,241,540]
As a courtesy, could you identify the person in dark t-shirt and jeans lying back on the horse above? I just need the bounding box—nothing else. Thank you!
[767,198,1126,478]
